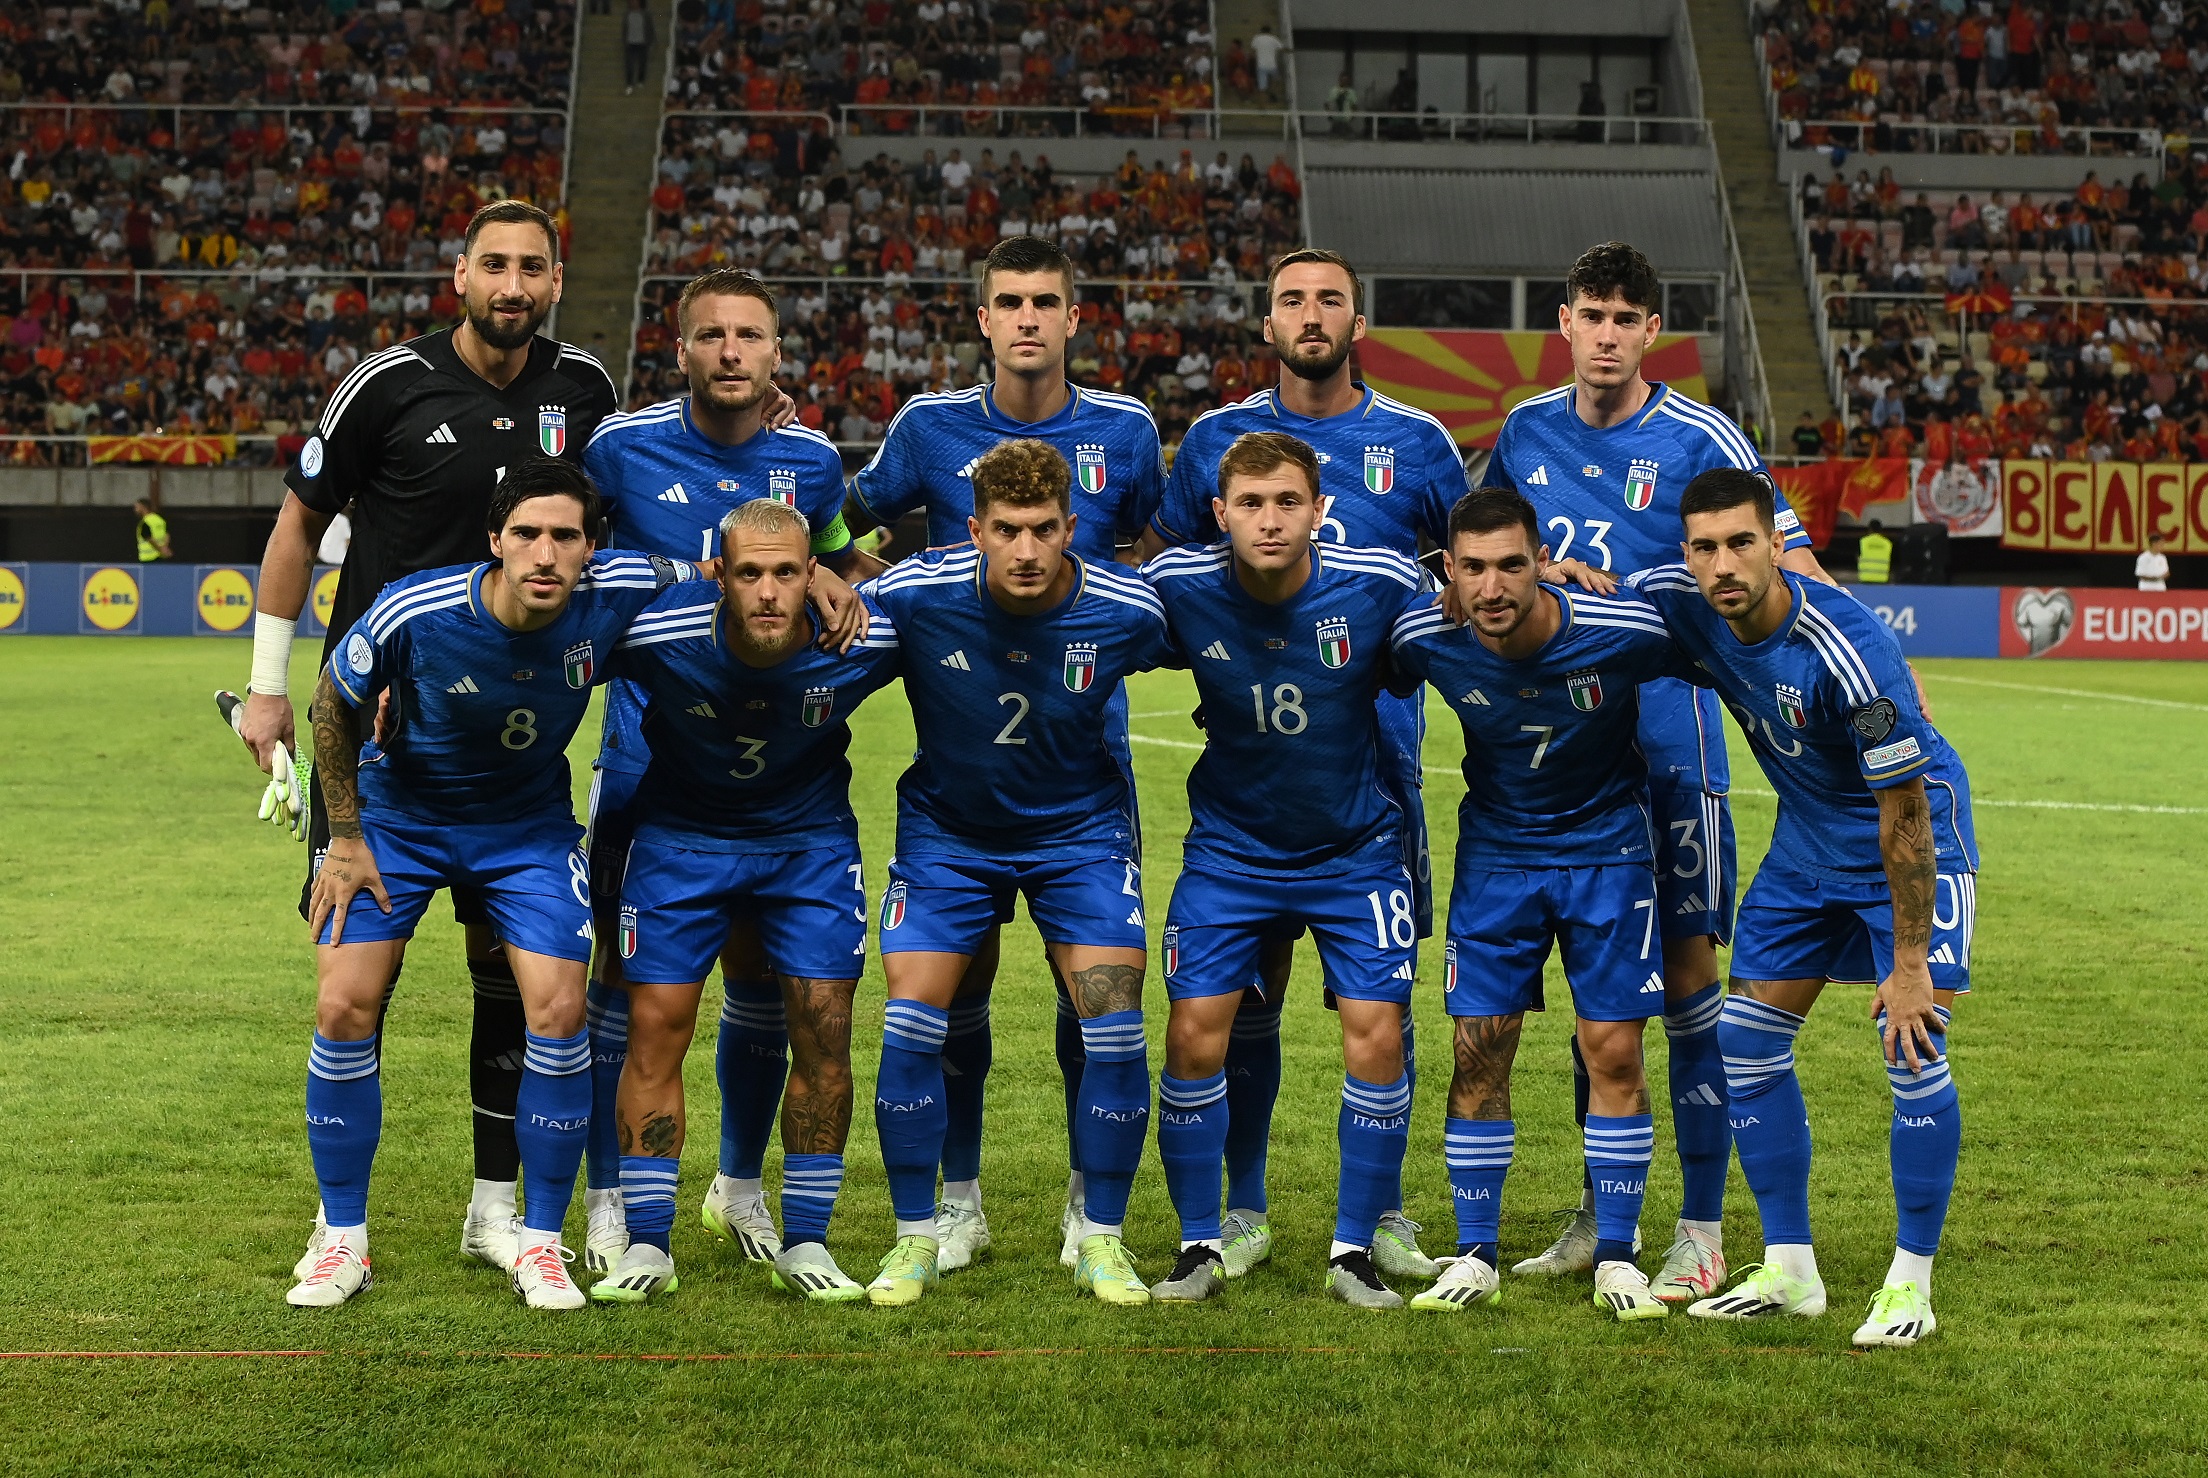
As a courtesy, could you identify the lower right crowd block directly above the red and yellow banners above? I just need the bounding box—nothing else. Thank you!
[1797,159,2208,460]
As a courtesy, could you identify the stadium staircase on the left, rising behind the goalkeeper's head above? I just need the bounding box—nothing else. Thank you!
[559,0,673,384]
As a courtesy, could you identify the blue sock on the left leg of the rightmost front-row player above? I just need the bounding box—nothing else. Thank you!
[1718,996,1811,1248]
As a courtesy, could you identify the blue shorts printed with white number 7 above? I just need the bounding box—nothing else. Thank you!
[1442,864,1663,1021]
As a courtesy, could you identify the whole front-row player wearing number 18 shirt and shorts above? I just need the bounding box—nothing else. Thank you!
[1144,431,1433,1308]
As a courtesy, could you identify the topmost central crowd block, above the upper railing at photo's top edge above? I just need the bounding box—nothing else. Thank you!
[667,0,1212,137]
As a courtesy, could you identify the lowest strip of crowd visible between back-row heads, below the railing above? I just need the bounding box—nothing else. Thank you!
[629,278,1276,446]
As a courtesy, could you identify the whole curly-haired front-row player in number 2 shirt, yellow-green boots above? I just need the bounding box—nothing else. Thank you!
[861,440,1172,1303]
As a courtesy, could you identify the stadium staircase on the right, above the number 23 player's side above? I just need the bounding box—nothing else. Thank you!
[1687,0,1833,428]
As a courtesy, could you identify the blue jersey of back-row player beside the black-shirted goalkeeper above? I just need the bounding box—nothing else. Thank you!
[583,395,850,771]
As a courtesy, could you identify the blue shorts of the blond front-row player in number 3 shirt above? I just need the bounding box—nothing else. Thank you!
[614,826,866,985]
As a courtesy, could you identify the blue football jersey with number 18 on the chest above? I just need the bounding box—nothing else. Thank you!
[1142,543,1433,877]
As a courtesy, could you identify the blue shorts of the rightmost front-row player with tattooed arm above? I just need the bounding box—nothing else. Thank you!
[1733,859,1978,994]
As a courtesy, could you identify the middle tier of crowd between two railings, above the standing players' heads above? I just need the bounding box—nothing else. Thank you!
[645,119,1303,285]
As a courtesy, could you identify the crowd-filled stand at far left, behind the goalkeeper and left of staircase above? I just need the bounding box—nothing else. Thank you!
[0,0,574,464]
